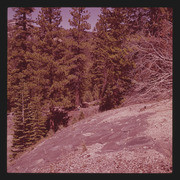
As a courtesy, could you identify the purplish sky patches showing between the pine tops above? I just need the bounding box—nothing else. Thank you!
[8,7,100,31]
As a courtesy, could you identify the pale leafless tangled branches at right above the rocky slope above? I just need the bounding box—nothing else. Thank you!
[126,20,173,104]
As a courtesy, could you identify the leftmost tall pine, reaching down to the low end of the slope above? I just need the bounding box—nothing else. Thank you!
[8,7,37,157]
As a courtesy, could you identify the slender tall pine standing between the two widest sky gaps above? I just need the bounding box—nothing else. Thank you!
[65,8,90,106]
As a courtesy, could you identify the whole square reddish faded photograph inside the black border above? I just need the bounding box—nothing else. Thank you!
[7,7,173,174]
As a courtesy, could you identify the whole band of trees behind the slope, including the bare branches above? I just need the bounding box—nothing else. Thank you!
[7,7,173,157]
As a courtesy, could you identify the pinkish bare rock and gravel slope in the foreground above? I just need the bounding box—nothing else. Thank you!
[7,99,173,173]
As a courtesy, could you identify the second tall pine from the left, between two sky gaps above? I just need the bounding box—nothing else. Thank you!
[20,8,63,142]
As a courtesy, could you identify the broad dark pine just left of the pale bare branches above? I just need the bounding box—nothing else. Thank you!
[92,8,133,110]
